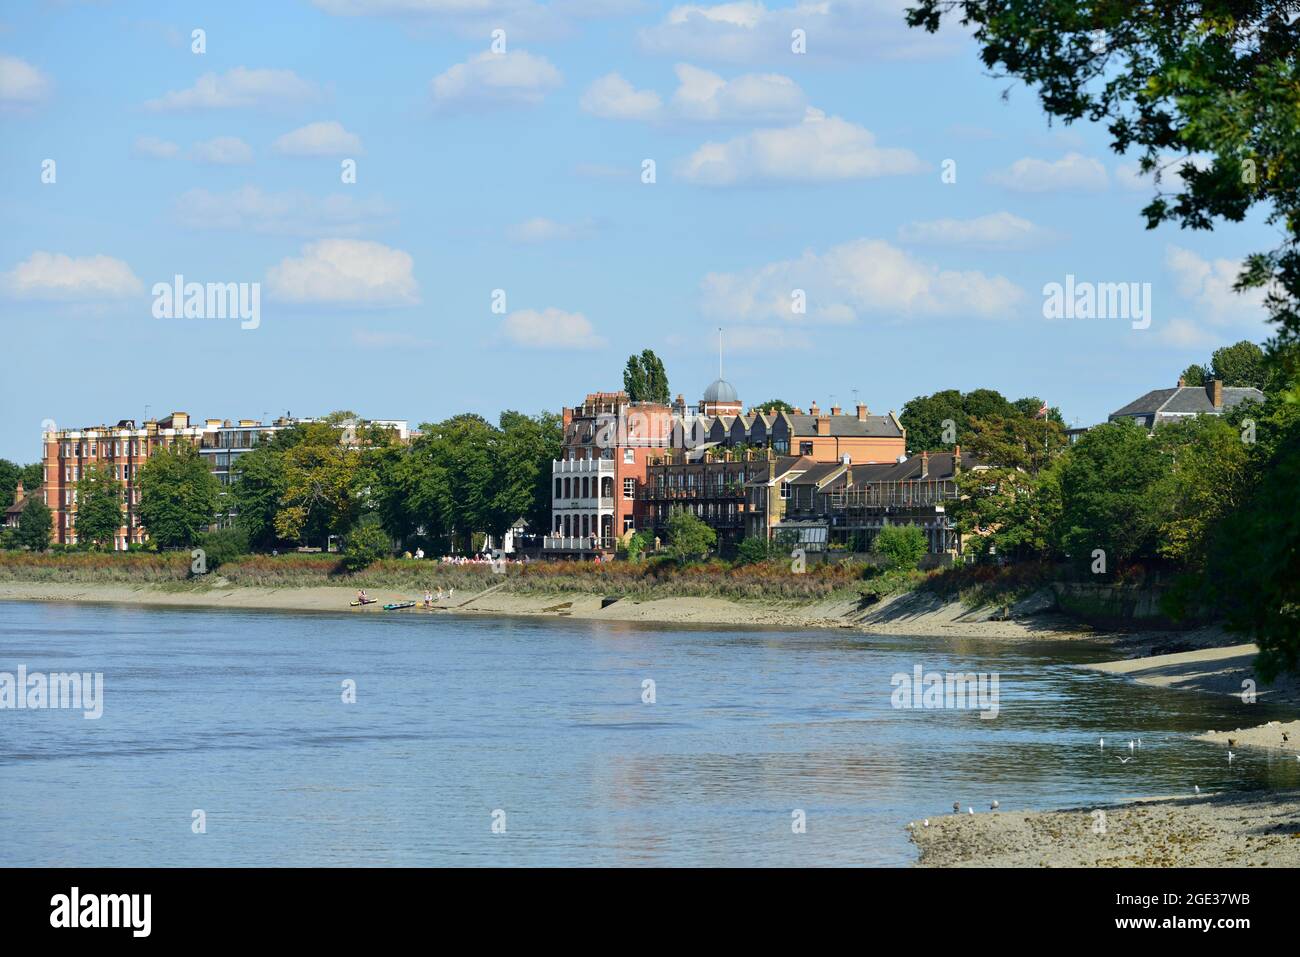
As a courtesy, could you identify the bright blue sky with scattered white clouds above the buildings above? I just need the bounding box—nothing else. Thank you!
[0,0,1273,462]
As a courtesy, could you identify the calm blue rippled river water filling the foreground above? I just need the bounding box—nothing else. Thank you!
[0,603,1300,866]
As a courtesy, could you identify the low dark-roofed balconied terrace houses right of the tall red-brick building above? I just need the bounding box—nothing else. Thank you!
[745,446,982,555]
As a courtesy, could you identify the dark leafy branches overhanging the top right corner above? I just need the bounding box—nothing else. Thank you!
[907,0,1300,341]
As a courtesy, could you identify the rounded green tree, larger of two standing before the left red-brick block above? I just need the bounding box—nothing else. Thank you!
[138,442,221,549]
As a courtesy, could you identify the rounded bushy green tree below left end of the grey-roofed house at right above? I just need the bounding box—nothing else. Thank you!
[1061,420,1169,571]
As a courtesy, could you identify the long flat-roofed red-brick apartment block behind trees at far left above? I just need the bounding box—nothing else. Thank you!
[42,412,412,551]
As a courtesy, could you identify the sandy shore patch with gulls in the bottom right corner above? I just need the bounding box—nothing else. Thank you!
[910,792,1300,867]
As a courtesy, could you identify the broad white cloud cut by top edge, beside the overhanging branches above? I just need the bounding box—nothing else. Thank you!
[638,0,961,65]
